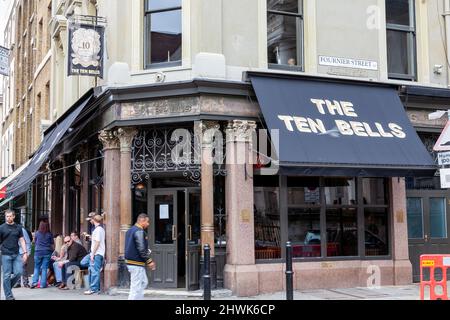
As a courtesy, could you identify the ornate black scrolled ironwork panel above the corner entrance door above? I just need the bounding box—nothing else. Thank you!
[131,128,201,185]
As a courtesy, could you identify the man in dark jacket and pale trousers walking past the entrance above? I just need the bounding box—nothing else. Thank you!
[125,213,156,300]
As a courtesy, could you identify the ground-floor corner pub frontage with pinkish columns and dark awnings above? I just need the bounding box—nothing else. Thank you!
[2,72,436,296]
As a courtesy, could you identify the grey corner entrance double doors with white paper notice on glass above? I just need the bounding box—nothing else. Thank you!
[148,188,200,290]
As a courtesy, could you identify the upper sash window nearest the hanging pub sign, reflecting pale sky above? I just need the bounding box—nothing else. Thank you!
[144,0,182,68]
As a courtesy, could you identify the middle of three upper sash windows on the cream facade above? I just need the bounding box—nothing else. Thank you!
[267,0,303,70]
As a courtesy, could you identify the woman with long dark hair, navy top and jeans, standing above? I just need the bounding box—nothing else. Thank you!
[30,221,54,289]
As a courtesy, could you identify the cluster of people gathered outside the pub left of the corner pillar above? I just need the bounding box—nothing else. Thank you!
[0,210,106,300]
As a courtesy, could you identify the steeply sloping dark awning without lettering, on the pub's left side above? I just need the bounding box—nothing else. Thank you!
[7,96,92,198]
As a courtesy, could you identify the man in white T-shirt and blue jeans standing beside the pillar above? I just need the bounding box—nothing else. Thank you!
[84,215,106,295]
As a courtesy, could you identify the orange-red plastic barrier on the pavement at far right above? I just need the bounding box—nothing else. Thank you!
[420,254,450,300]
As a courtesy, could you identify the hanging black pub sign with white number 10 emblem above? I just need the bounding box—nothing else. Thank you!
[68,19,105,78]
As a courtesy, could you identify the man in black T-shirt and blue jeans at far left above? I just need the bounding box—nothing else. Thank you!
[0,209,29,300]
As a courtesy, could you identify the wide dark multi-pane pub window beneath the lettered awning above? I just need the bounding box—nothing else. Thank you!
[254,176,390,260]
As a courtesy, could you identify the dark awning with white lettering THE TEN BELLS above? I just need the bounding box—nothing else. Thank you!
[249,73,437,177]
